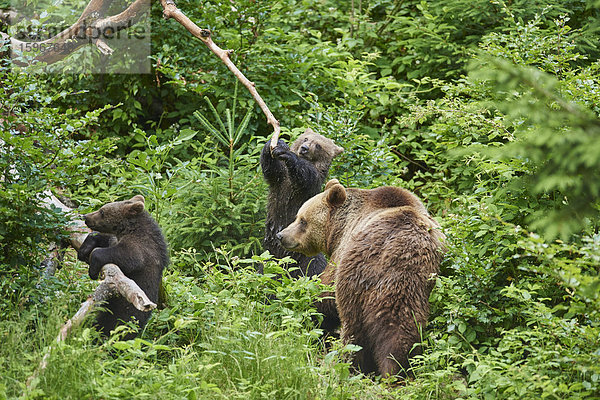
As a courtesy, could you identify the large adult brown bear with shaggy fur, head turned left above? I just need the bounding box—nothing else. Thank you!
[278,179,443,376]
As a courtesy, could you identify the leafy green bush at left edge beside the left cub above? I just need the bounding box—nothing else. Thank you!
[0,57,111,315]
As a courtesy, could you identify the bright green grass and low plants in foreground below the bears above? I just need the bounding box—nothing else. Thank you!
[0,254,389,399]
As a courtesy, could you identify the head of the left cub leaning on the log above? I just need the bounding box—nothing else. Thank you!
[83,195,144,234]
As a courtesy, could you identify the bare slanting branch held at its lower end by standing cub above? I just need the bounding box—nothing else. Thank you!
[160,0,281,149]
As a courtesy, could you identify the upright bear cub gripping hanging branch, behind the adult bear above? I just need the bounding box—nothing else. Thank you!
[260,128,344,278]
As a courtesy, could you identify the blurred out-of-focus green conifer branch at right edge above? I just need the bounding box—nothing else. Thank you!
[472,56,600,239]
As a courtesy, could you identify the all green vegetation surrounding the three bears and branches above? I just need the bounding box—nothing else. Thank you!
[0,0,600,399]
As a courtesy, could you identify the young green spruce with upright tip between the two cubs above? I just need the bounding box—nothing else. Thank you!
[165,97,266,254]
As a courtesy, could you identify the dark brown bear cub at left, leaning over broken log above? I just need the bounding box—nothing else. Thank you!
[77,195,169,339]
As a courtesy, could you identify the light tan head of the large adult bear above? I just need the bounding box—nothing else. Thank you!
[277,179,346,256]
